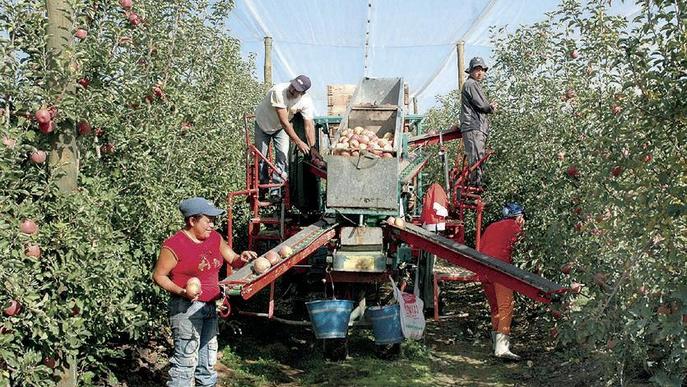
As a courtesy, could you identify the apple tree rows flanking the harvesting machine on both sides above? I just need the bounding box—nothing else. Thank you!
[0,0,687,386]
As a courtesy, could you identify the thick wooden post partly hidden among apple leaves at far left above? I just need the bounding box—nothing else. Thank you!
[46,0,79,192]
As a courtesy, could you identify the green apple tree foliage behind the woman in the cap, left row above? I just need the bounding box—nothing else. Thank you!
[0,0,261,386]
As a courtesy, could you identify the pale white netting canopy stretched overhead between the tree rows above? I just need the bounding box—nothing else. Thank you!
[227,0,639,115]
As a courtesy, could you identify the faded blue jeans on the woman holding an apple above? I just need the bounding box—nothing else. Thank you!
[167,297,218,387]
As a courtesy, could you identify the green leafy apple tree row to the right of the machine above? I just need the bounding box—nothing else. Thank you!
[430,0,687,384]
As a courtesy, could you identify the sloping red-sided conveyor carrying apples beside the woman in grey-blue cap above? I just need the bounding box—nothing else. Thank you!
[220,220,337,300]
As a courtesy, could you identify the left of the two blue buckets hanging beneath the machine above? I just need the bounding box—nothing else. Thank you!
[305,300,353,339]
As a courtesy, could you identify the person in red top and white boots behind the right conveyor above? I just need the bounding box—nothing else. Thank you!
[480,203,525,360]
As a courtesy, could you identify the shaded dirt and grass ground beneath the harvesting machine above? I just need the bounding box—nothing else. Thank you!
[116,283,644,386]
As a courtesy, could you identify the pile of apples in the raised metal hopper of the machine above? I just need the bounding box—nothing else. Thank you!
[332,126,394,159]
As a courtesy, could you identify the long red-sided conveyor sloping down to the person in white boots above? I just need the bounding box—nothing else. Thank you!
[388,224,565,302]
